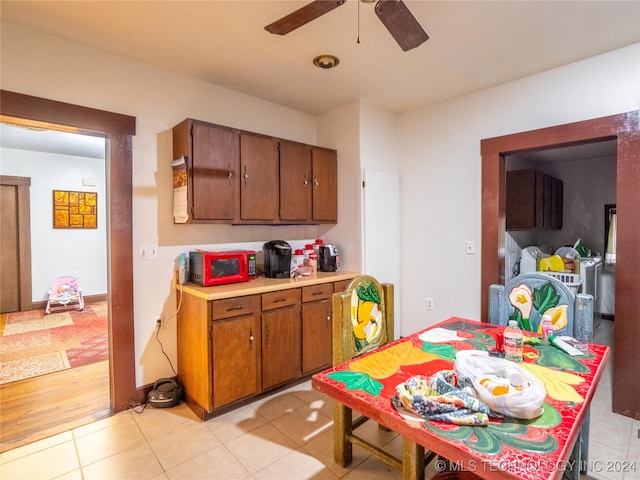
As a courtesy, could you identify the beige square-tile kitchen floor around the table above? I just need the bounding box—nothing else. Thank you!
[0,320,640,480]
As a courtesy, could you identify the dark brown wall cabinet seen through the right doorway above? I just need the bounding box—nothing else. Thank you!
[506,169,563,231]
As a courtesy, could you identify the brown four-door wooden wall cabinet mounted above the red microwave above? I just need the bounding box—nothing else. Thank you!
[173,119,338,224]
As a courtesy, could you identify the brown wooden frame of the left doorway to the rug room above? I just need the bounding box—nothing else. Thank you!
[0,90,141,412]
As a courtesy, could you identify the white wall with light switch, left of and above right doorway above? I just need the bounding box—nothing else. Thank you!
[398,44,640,335]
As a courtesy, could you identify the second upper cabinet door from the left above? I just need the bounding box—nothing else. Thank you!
[240,132,279,223]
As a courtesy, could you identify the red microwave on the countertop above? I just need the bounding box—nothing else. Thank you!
[189,250,256,287]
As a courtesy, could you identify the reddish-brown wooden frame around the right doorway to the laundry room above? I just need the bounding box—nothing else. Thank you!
[480,110,640,420]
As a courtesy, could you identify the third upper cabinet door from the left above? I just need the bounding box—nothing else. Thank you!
[279,142,312,221]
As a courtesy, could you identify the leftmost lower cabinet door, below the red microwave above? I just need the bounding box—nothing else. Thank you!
[212,314,260,408]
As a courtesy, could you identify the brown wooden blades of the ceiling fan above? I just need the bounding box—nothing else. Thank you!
[264,0,429,52]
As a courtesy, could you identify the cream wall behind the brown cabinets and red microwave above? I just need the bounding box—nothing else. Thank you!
[0,21,359,386]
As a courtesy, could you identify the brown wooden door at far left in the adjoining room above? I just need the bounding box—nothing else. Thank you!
[0,175,32,313]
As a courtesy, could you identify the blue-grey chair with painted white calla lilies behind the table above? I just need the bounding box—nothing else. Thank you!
[489,272,593,473]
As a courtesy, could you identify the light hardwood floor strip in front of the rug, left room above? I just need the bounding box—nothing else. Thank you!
[0,360,111,452]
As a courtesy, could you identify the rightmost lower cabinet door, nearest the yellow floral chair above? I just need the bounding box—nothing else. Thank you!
[302,300,332,374]
